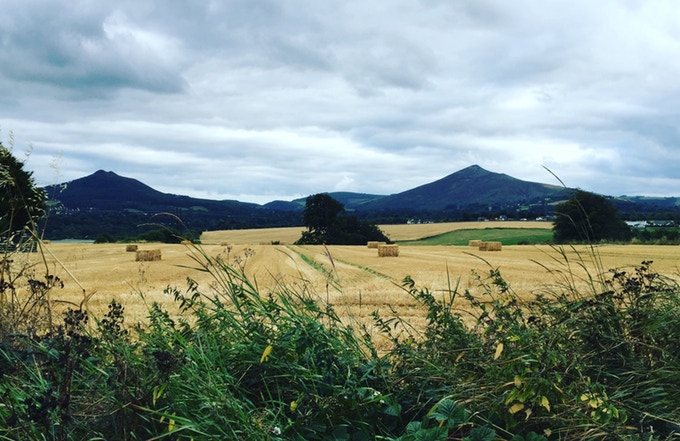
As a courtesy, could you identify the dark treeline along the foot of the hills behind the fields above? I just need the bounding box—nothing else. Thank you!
[40,192,680,243]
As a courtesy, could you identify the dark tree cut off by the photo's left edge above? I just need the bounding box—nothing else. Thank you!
[0,142,45,242]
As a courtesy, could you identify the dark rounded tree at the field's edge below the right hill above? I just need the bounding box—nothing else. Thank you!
[553,190,632,243]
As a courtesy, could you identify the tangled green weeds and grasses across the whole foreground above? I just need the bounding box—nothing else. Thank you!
[0,237,680,441]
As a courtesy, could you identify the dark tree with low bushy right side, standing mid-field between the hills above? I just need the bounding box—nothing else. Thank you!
[296,193,389,245]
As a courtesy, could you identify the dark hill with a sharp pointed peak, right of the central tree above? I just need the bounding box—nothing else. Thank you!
[358,165,569,212]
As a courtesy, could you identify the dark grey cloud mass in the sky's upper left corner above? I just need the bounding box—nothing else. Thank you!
[0,2,184,96]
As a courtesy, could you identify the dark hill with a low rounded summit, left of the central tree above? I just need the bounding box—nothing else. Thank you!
[44,170,300,239]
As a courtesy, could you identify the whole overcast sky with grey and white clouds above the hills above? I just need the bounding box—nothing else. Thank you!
[0,0,680,203]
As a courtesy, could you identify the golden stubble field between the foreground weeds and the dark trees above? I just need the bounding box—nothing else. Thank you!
[15,222,680,346]
